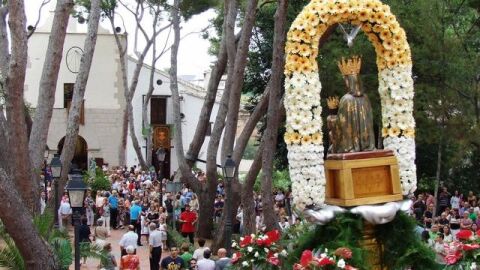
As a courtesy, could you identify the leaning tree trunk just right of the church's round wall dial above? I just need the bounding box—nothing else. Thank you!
[59,0,101,190]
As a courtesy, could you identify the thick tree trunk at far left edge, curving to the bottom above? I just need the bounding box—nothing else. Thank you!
[0,1,56,270]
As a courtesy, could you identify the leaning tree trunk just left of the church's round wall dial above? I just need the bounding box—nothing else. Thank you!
[28,0,73,173]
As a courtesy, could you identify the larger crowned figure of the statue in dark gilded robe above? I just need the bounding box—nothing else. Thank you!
[331,56,375,153]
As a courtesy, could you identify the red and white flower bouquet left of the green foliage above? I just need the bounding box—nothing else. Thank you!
[231,230,288,269]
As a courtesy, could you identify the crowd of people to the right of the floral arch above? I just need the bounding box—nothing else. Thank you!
[411,187,480,263]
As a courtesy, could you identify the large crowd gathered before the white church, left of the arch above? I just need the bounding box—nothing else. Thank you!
[50,167,298,270]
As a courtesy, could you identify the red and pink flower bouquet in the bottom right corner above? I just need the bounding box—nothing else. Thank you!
[444,230,480,270]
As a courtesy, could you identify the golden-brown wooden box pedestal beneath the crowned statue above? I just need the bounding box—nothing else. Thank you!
[325,150,403,207]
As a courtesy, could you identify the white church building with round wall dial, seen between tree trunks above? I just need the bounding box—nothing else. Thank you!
[25,14,220,176]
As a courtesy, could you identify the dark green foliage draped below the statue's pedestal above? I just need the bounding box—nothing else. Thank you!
[283,212,441,270]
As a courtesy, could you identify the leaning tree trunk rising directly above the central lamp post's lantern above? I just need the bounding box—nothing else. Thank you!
[221,0,258,162]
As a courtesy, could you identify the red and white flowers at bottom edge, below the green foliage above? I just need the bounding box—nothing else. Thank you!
[293,247,357,270]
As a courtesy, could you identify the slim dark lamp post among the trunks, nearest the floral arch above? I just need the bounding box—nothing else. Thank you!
[223,155,237,256]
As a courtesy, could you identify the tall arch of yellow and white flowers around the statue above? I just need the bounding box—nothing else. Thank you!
[284,0,416,210]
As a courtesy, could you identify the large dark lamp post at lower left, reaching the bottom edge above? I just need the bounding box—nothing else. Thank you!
[66,174,87,270]
